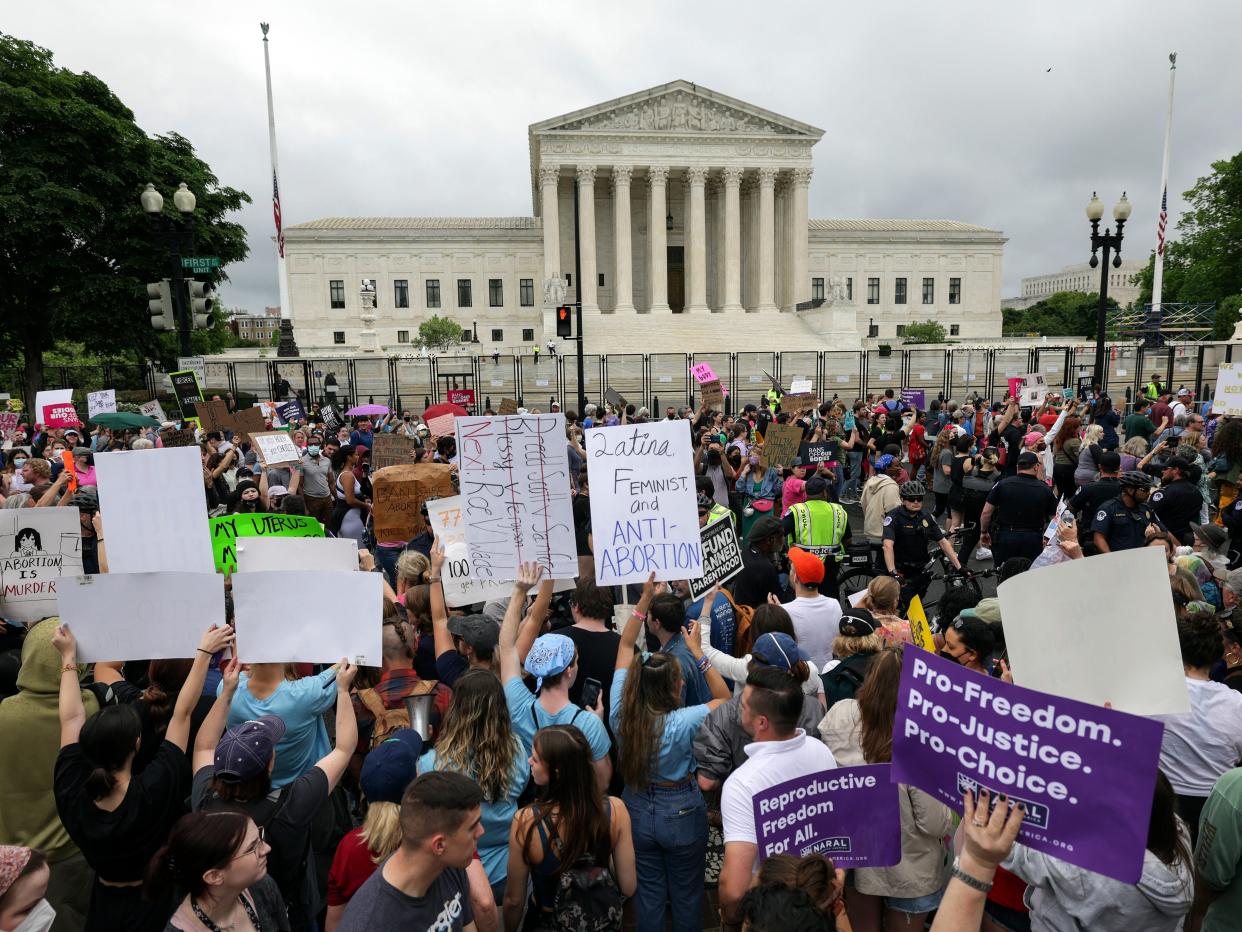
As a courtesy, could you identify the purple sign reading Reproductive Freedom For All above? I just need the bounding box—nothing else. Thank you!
[754,764,902,867]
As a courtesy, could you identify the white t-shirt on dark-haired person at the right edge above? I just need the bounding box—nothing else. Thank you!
[1153,676,1242,797]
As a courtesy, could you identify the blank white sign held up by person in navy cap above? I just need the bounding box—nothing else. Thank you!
[232,570,384,666]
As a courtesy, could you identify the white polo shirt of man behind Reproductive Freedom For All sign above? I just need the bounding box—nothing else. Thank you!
[720,728,837,870]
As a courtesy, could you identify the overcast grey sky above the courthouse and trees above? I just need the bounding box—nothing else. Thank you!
[9,0,1242,311]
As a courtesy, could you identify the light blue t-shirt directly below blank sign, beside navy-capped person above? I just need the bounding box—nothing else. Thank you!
[216,667,337,789]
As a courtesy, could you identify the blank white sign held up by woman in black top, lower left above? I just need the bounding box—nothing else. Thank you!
[60,576,226,664]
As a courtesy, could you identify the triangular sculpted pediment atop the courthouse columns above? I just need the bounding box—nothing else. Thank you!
[530,81,823,140]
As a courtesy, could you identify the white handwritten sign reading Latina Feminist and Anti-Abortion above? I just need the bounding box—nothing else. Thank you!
[586,420,703,585]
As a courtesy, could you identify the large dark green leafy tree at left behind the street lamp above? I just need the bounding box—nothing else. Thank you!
[0,34,250,399]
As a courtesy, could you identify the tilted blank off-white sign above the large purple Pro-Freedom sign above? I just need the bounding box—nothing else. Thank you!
[996,546,1190,715]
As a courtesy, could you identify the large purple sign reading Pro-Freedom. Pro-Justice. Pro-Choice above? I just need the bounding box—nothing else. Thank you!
[893,650,1164,884]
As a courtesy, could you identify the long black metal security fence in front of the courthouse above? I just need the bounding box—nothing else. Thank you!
[0,343,1233,413]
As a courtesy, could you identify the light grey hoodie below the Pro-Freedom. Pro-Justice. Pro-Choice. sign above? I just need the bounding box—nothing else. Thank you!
[1004,825,1195,932]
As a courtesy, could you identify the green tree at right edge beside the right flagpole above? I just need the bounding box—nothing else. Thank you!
[1135,153,1242,308]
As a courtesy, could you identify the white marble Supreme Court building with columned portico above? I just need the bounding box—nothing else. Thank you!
[284,81,1005,354]
